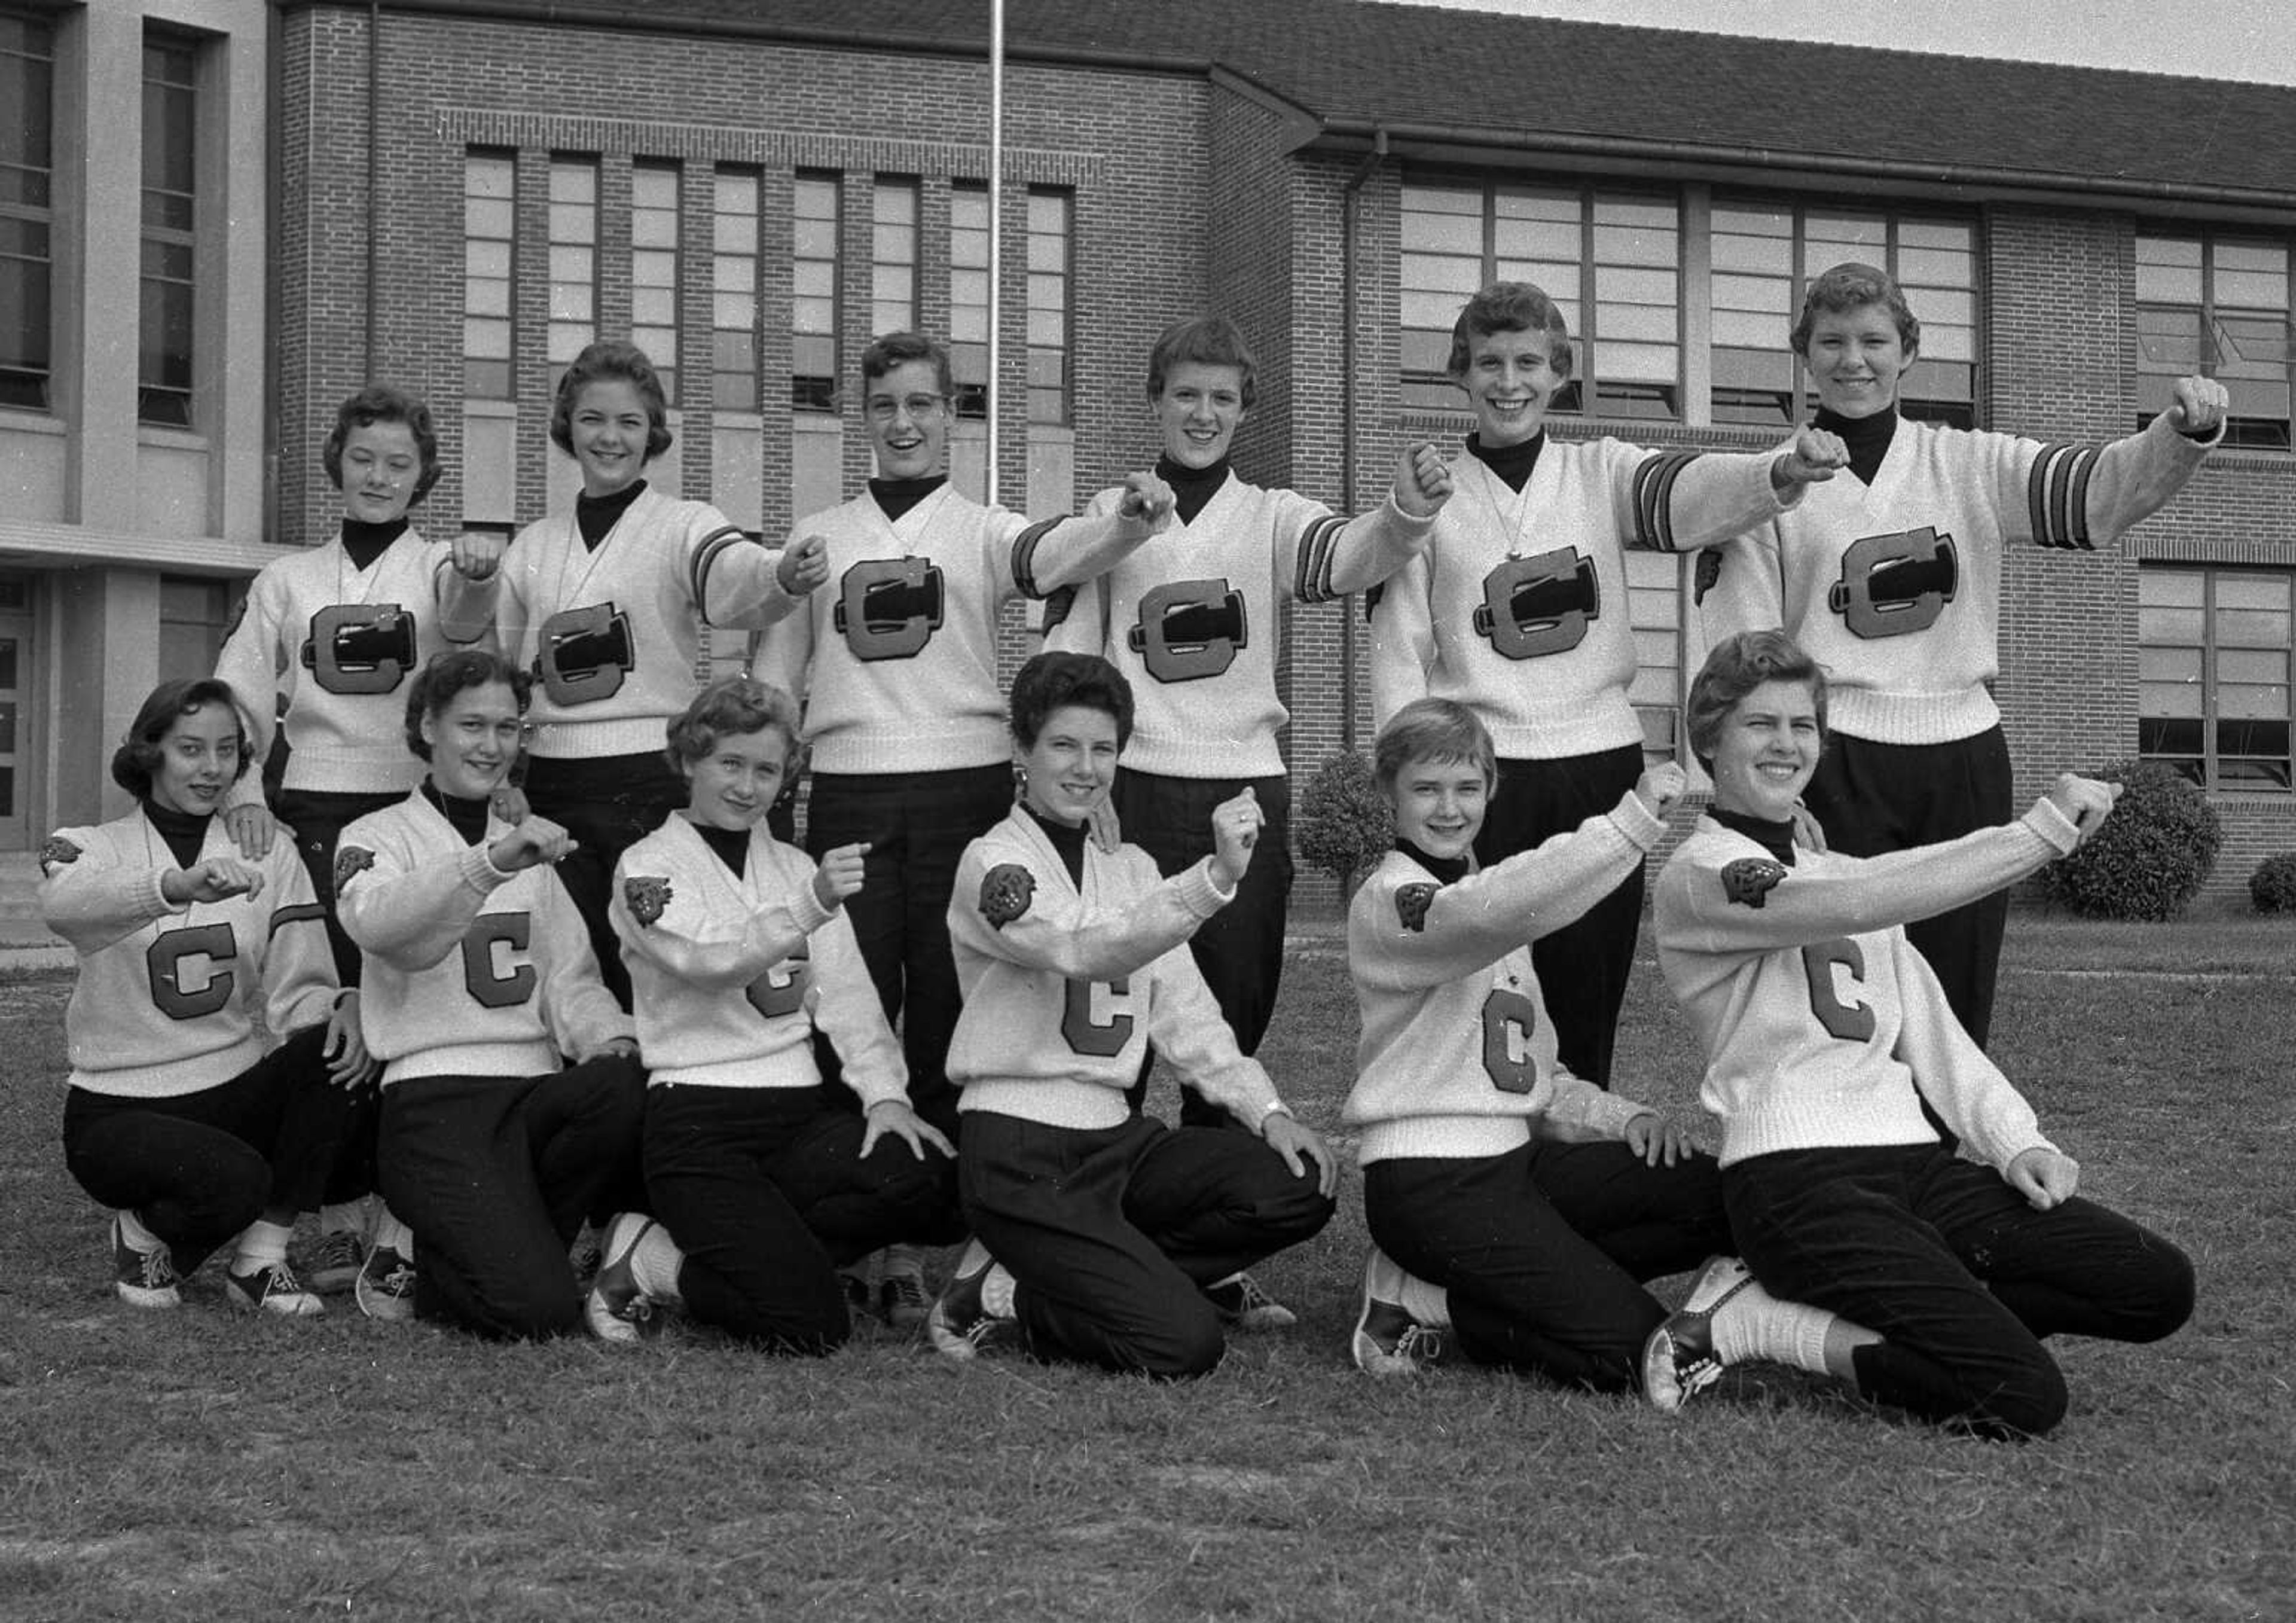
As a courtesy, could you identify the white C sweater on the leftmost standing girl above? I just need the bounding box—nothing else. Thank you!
[216,530,498,806]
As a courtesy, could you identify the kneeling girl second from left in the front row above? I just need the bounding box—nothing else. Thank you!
[335,649,645,1341]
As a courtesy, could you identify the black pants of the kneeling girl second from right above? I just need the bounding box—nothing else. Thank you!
[1364,1141,1729,1391]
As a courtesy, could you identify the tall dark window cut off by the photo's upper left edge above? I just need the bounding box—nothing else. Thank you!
[0,11,55,411]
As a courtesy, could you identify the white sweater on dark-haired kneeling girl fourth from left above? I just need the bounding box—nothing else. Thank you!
[948,806,1279,1130]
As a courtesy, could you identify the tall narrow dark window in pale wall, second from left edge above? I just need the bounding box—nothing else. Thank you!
[136,32,200,429]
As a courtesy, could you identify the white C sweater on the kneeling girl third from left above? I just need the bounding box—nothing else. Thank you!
[606,813,909,1109]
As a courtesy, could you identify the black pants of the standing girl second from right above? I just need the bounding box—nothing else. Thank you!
[1474,744,1642,1088]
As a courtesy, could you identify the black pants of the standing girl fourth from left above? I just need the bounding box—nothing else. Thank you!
[1113,771,1293,1127]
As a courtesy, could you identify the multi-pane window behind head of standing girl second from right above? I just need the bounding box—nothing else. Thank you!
[1403,181,1683,420]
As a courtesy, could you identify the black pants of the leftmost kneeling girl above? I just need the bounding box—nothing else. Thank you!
[65,1026,358,1274]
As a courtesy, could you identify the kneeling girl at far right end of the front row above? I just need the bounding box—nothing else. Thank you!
[1644,631,2193,1435]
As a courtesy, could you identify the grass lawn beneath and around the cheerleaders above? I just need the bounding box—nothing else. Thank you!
[0,914,2296,1623]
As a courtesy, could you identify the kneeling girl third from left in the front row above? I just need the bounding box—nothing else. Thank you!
[597,677,964,1354]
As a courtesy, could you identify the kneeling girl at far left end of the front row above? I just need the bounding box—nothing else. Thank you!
[39,679,374,1317]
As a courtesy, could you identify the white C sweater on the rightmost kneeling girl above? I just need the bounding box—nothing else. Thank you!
[1656,799,2078,1171]
